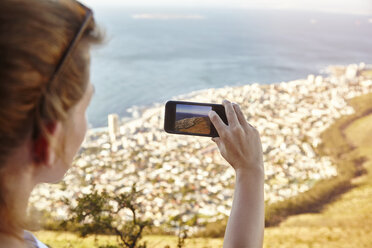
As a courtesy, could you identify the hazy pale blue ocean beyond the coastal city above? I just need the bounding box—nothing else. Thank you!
[88,7,372,127]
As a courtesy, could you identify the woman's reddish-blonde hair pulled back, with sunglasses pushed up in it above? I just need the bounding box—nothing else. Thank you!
[0,0,102,237]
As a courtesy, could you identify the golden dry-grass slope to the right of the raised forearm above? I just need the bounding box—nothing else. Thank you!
[264,94,372,248]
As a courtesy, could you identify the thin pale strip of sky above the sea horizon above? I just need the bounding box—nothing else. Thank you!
[81,0,372,15]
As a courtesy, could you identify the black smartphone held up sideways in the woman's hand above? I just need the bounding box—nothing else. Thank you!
[164,101,228,137]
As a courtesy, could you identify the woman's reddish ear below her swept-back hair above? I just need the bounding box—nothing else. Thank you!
[32,121,61,167]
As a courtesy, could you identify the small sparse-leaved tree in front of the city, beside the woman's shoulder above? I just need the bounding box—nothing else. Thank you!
[62,184,152,248]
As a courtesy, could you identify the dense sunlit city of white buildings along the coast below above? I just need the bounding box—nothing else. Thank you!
[30,63,372,231]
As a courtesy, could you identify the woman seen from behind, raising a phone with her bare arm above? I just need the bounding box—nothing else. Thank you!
[0,0,264,248]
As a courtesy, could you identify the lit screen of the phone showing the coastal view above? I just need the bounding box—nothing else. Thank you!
[174,104,212,135]
